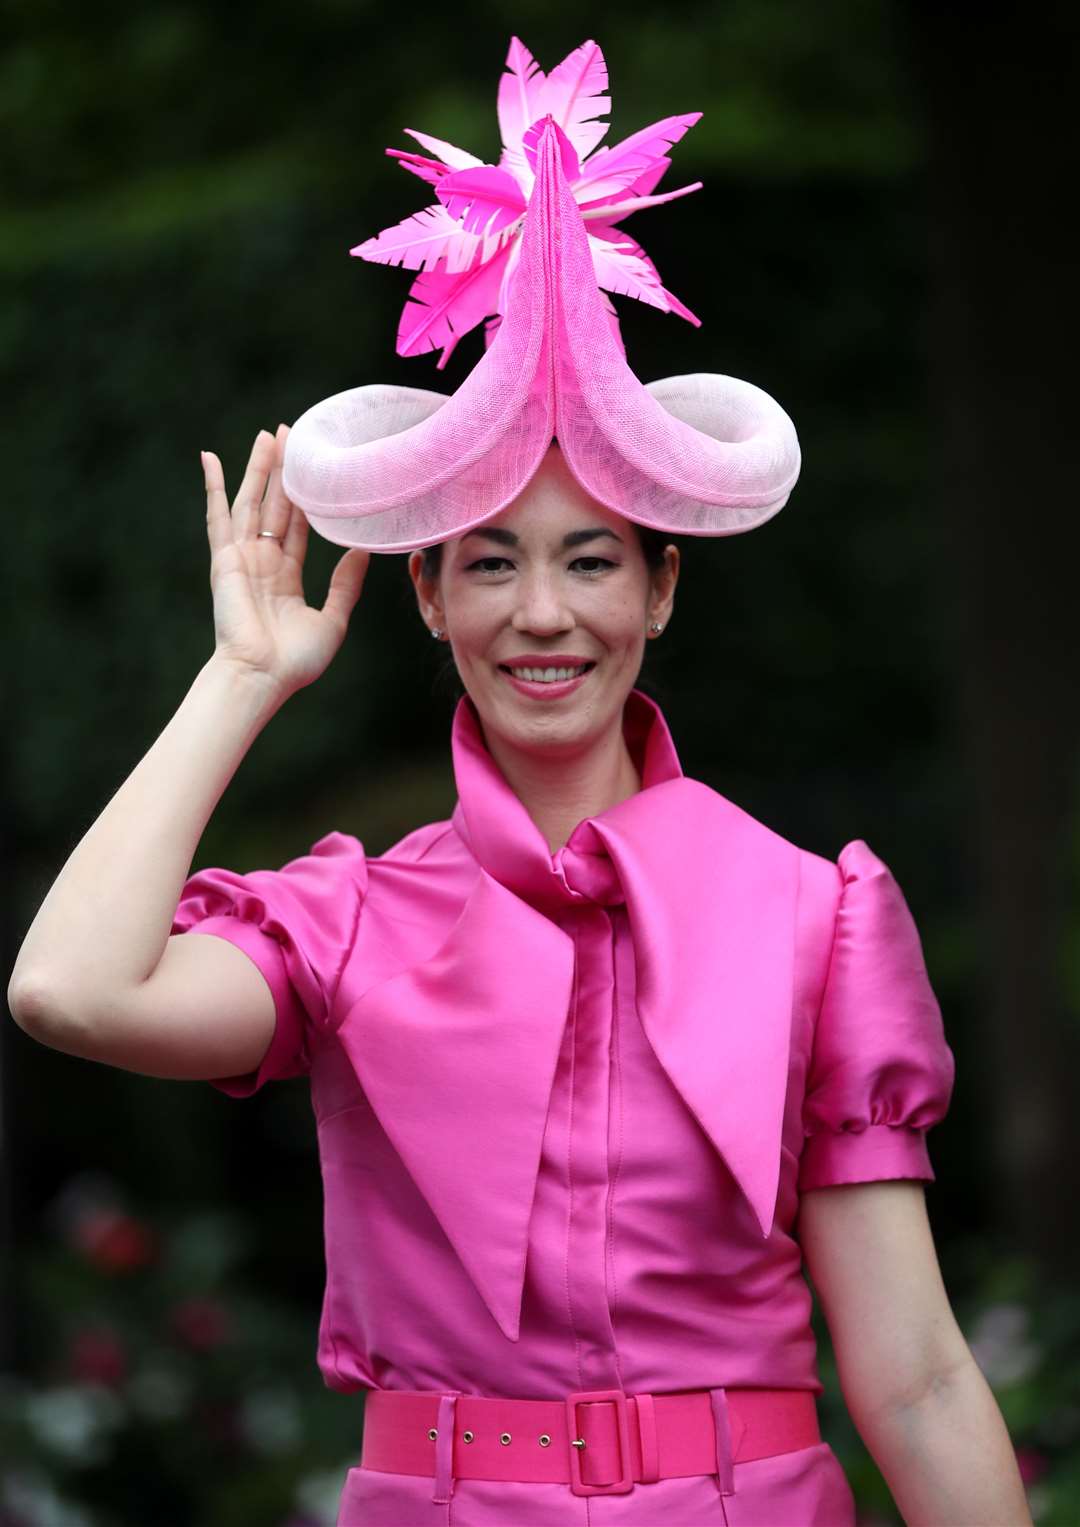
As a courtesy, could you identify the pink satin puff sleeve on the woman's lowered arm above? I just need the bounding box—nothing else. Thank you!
[799,838,955,1191]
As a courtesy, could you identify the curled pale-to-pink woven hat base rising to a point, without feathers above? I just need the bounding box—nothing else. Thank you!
[283,118,800,551]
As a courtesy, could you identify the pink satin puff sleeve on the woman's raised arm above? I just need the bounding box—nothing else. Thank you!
[171,832,367,1098]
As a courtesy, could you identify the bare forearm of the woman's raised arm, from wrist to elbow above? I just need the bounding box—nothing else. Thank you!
[9,658,283,1028]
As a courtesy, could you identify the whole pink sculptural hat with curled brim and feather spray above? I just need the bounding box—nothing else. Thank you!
[283,38,799,551]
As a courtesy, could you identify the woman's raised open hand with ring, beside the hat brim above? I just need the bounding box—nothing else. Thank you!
[202,425,371,695]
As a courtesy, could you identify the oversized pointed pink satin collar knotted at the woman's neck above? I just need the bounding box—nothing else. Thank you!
[339,690,797,1341]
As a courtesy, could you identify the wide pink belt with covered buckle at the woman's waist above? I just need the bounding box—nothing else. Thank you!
[361,1388,822,1501]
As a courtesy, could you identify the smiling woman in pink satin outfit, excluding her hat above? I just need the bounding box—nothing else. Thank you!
[12,428,1030,1527]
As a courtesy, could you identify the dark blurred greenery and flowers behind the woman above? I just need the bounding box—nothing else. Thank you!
[0,0,1080,1527]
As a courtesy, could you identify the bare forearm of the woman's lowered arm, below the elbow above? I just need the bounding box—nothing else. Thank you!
[852,1359,1031,1527]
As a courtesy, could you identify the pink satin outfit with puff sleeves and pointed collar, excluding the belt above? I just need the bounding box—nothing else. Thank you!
[173,690,955,1527]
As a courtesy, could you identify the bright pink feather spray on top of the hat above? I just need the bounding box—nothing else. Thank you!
[350,37,701,371]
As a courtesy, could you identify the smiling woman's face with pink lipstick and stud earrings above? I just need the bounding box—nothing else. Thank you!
[409,446,678,756]
